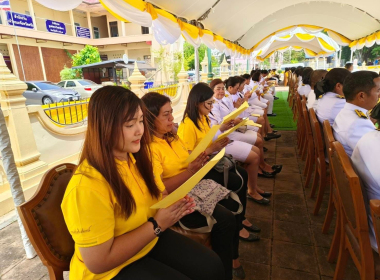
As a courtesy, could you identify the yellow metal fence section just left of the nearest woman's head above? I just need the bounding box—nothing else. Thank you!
[42,99,90,126]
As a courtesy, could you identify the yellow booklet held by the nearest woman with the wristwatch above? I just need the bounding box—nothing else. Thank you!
[150,148,225,209]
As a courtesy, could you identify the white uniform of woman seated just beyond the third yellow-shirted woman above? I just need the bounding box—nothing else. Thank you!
[208,98,257,162]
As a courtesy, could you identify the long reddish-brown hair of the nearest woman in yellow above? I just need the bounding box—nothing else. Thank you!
[79,86,160,218]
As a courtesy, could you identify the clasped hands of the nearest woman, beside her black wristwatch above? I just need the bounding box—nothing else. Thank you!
[154,195,195,231]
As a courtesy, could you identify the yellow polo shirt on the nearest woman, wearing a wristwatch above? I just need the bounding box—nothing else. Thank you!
[61,154,165,280]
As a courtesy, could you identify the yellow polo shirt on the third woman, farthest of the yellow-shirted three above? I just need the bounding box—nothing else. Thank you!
[177,116,210,151]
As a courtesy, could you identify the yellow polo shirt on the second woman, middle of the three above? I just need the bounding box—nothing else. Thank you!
[150,136,189,179]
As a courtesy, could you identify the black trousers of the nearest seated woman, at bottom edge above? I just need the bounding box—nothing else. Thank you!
[112,229,225,280]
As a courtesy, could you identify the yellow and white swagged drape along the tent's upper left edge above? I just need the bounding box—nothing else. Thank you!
[100,0,251,58]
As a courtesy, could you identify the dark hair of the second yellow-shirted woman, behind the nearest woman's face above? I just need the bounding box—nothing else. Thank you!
[141,92,176,142]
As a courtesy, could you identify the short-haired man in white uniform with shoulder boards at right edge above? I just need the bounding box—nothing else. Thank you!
[332,71,380,156]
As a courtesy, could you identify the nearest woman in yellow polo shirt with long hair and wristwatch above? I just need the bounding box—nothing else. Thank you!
[61,86,224,280]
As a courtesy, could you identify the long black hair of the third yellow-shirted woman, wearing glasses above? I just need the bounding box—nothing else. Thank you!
[182,83,214,130]
